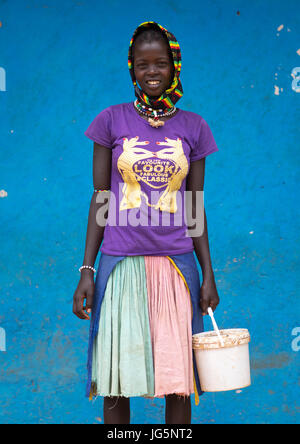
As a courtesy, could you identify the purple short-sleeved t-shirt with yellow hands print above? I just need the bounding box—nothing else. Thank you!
[85,102,218,256]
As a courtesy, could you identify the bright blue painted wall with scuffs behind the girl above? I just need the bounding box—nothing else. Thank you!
[0,0,300,424]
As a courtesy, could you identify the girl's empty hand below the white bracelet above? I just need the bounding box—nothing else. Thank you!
[73,270,95,320]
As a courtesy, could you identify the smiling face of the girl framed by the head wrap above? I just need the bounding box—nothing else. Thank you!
[133,40,174,99]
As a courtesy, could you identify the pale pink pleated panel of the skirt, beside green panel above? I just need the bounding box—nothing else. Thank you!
[144,256,194,398]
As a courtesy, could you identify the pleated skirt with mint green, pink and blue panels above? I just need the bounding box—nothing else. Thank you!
[87,253,203,404]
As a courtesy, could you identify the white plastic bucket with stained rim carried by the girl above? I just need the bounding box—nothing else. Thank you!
[193,308,251,392]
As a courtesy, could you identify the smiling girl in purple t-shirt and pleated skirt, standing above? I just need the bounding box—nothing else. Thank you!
[73,21,219,424]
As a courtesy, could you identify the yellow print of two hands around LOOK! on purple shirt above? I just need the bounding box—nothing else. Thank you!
[117,136,188,213]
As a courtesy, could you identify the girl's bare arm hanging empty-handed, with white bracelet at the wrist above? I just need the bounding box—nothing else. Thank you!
[73,143,111,319]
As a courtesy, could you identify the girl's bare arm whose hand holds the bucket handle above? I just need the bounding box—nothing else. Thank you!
[186,157,220,315]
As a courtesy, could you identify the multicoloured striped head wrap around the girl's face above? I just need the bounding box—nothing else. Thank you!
[128,21,183,110]
